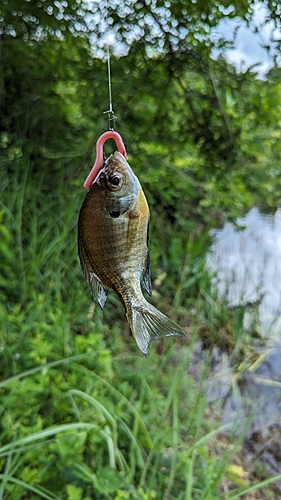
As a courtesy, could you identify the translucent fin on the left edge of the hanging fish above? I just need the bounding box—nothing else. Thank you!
[78,237,108,309]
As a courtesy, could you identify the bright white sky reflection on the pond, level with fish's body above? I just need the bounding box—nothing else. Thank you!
[210,208,281,336]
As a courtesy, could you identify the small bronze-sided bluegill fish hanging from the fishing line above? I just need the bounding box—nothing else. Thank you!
[78,151,185,355]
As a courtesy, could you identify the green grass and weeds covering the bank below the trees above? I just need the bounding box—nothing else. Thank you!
[0,158,274,500]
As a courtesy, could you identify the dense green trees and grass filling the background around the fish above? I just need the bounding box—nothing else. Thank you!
[0,0,281,500]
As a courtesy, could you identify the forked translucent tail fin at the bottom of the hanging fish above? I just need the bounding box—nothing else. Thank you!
[127,301,185,356]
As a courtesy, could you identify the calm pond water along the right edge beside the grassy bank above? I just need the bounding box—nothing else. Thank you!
[197,208,281,488]
